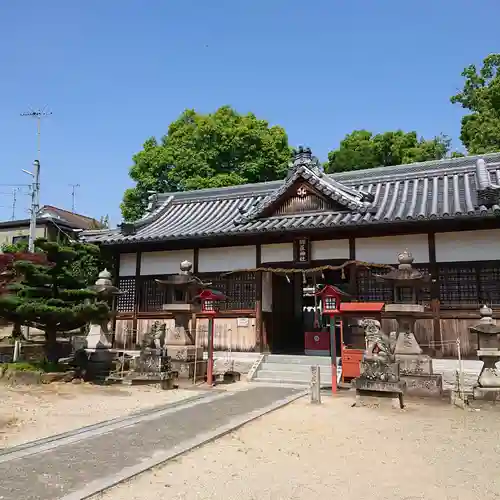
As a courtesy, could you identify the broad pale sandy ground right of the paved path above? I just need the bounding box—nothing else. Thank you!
[98,394,500,500]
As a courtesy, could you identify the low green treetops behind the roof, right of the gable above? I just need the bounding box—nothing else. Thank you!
[325,130,450,172]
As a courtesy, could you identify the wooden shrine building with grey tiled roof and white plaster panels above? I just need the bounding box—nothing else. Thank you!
[82,148,500,356]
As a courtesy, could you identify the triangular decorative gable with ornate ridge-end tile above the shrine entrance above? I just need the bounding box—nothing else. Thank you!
[235,148,373,224]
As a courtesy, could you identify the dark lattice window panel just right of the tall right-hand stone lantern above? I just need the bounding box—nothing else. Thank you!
[439,264,479,309]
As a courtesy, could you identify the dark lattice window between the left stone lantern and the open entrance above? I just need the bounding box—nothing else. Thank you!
[200,272,256,311]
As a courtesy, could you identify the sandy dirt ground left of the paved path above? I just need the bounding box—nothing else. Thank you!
[0,383,197,449]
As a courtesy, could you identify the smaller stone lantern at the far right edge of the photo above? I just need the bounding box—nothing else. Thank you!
[469,306,500,399]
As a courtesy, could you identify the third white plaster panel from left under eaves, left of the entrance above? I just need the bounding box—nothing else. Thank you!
[198,246,257,273]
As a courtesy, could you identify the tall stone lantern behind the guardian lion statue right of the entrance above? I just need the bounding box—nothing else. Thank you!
[377,250,442,396]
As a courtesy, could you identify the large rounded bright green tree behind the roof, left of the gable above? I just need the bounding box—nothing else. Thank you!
[121,106,291,221]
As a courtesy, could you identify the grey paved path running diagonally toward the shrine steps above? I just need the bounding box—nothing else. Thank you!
[0,386,303,500]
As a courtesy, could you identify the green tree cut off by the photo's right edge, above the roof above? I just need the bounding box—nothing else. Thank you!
[451,54,500,154]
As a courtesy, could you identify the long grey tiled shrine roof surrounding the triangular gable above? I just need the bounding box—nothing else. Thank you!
[82,153,500,244]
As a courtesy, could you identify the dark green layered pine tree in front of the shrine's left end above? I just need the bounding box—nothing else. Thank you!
[0,239,109,362]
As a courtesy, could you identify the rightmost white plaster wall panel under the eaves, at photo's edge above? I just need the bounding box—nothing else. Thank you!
[436,229,500,262]
